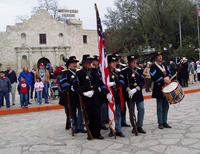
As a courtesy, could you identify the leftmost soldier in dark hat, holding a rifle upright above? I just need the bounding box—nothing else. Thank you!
[62,56,87,133]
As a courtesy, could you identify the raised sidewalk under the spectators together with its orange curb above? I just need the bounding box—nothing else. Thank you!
[0,82,200,115]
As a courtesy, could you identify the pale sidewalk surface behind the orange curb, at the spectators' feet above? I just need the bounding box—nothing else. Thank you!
[0,82,200,110]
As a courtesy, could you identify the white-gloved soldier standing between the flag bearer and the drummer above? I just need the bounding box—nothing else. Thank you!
[122,55,146,134]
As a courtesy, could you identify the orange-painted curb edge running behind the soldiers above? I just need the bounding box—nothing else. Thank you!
[0,88,200,116]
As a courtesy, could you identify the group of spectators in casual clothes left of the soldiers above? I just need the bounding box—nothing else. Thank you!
[0,63,64,109]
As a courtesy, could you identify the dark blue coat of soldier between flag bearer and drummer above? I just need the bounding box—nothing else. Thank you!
[122,67,144,102]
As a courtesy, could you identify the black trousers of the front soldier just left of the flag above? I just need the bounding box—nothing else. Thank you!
[83,93,101,137]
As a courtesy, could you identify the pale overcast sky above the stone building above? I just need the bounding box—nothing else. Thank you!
[0,0,114,32]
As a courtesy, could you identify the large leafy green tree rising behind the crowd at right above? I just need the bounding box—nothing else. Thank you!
[104,0,198,59]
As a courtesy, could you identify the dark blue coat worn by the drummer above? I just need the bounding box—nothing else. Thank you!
[150,63,172,99]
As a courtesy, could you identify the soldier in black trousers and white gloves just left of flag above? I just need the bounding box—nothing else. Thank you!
[73,55,104,139]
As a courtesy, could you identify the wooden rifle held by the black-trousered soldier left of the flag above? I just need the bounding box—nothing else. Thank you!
[77,77,93,140]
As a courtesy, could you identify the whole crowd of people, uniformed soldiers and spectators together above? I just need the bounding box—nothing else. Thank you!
[0,52,200,139]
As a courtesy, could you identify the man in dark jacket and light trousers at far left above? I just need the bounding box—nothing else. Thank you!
[5,65,17,105]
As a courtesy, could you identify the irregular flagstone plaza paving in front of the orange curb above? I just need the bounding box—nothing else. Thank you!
[0,92,200,154]
